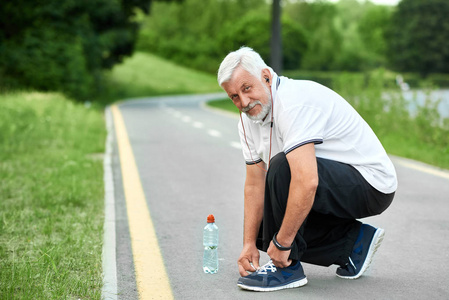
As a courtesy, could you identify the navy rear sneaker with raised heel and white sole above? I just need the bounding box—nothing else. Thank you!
[337,224,385,279]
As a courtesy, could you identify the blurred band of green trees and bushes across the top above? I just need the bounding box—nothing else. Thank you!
[0,0,449,100]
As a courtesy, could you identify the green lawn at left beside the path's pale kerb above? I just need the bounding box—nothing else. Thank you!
[0,92,105,299]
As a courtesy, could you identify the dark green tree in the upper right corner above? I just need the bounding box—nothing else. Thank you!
[387,0,449,76]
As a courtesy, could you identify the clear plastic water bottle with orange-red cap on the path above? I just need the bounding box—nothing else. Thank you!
[203,215,218,274]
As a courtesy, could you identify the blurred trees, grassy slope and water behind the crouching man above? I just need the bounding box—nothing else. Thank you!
[0,0,449,185]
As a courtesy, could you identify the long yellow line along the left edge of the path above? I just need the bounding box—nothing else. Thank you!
[111,105,173,299]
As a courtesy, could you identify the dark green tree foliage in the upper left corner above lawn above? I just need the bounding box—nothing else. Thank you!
[0,0,151,98]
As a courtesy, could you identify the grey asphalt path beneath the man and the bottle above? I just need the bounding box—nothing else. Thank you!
[105,94,449,299]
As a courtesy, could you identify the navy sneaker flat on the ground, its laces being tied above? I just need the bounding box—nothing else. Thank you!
[237,260,307,292]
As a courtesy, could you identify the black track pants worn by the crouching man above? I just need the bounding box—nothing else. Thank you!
[257,152,394,266]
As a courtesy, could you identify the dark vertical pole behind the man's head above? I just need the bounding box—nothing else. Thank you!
[270,0,282,75]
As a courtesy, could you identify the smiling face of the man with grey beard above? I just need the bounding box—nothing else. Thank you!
[222,68,271,120]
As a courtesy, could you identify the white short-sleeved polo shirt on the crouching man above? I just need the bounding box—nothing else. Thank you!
[239,74,397,194]
